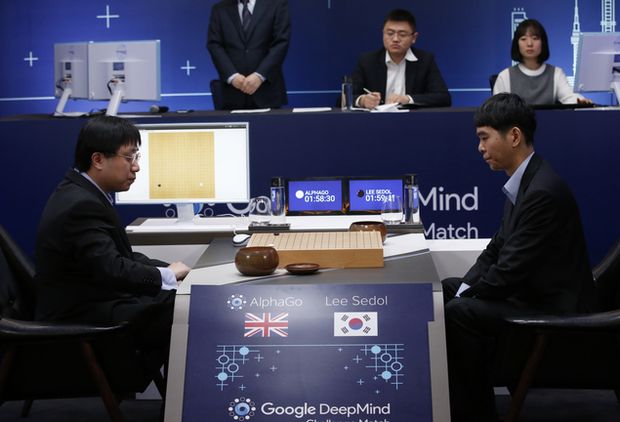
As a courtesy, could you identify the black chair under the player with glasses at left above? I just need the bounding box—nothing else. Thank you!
[0,226,165,421]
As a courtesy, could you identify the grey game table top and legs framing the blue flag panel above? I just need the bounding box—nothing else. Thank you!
[165,234,450,422]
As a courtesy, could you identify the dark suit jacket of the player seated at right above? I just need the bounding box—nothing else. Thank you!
[462,154,594,313]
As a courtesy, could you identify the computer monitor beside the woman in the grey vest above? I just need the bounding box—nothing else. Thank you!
[574,32,620,101]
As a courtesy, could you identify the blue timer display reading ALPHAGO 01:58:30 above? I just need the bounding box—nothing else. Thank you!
[288,180,342,212]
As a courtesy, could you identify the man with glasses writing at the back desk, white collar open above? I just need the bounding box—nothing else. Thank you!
[353,9,452,109]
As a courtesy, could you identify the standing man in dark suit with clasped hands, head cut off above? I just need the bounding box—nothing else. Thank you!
[207,0,291,109]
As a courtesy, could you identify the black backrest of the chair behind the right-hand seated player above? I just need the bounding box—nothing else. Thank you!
[592,239,620,311]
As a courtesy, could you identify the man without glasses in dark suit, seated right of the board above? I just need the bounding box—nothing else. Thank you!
[442,94,593,422]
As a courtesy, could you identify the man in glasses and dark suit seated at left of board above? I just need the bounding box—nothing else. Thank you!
[35,116,189,376]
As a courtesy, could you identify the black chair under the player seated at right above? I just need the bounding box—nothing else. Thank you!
[494,240,620,422]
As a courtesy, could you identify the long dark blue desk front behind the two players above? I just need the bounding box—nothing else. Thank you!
[0,109,620,263]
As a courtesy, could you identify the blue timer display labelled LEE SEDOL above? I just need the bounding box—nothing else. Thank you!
[349,179,403,211]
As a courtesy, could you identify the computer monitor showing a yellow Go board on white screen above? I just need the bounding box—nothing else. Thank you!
[116,122,250,222]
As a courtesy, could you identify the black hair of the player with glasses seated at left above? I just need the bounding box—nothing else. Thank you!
[74,116,141,171]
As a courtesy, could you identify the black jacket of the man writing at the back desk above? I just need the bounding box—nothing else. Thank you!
[353,47,452,107]
